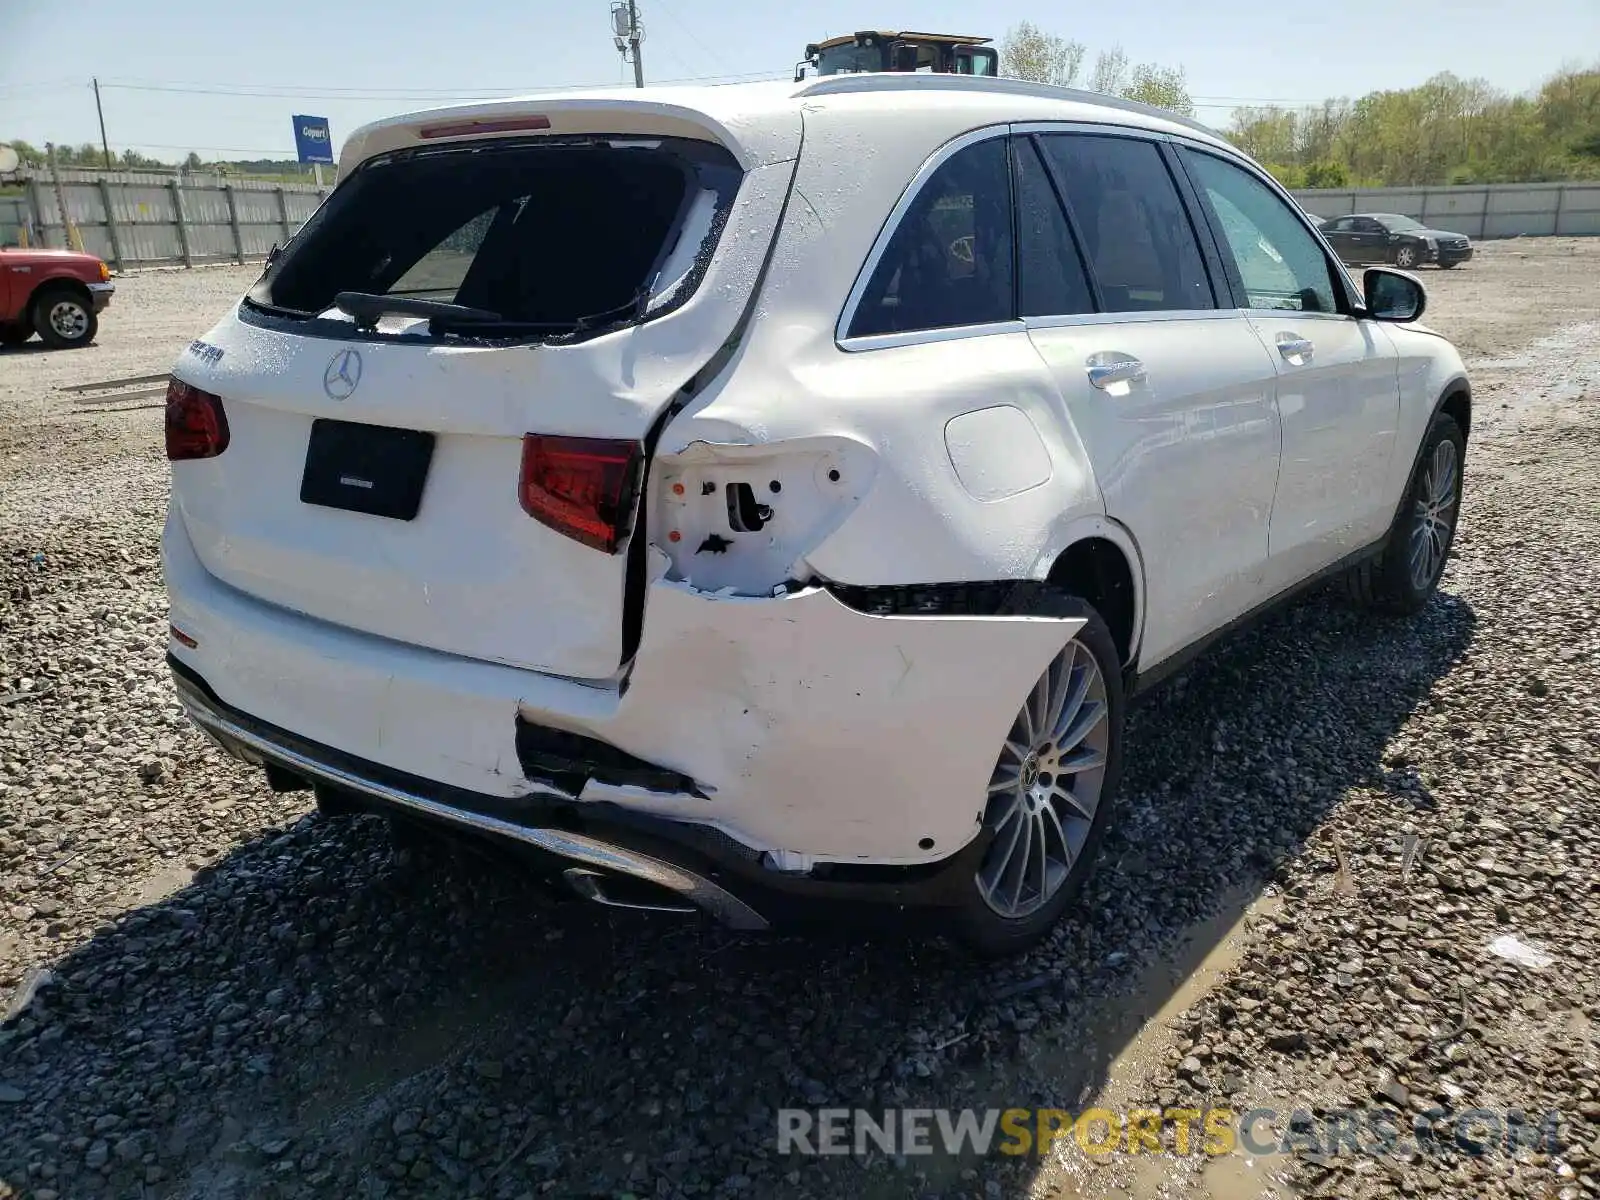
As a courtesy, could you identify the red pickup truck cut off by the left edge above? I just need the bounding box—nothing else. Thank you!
[0,246,115,350]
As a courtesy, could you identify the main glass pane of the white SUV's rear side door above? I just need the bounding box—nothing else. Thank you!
[1038,133,1216,312]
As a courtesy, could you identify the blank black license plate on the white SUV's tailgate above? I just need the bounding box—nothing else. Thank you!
[301,418,434,522]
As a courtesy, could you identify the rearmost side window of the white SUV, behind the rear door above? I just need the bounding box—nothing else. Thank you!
[848,138,1013,338]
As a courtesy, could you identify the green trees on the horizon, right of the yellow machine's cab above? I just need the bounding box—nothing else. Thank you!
[1000,21,1600,187]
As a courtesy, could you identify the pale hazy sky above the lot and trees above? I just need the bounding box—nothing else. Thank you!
[0,0,1600,158]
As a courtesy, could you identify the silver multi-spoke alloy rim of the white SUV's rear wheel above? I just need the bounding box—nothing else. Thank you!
[978,640,1110,920]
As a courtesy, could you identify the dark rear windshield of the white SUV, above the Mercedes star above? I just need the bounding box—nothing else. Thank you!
[245,138,741,339]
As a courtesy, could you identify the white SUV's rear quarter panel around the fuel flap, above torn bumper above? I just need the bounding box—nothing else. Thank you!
[653,102,1106,590]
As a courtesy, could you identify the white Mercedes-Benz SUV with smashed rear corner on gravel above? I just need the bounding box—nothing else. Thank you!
[165,75,1470,954]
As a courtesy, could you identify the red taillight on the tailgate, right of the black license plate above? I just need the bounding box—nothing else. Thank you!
[517,434,643,554]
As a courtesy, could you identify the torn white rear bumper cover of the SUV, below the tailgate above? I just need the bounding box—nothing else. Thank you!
[163,514,1078,875]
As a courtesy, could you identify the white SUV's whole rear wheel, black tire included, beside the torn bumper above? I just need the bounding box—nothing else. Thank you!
[949,592,1125,958]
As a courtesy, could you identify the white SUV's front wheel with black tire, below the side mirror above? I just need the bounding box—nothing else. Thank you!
[1346,413,1467,616]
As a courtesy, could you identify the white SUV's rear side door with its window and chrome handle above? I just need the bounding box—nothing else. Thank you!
[1021,131,1280,669]
